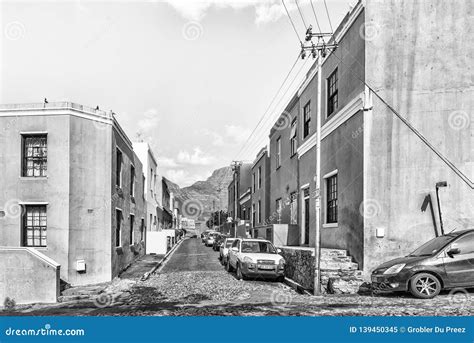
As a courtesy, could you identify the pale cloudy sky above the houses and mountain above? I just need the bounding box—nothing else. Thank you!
[0,0,355,187]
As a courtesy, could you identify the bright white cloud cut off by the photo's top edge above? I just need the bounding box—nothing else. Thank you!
[165,0,288,24]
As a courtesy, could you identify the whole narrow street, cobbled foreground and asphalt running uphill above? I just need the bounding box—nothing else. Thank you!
[0,238,474,316]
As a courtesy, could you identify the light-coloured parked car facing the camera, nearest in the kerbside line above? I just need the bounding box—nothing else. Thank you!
[226,238,285,281]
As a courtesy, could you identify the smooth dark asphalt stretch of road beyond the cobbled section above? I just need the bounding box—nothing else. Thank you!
[160,237,223,273]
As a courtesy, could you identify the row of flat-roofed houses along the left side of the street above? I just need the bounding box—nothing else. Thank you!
[0,102,191,299]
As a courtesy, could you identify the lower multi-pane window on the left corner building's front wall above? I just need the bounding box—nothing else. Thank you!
[23,205,47,247]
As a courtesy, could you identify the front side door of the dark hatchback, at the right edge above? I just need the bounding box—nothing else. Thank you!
[444,233,474,287]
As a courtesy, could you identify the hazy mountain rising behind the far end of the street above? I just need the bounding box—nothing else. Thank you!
[167,167,232,225]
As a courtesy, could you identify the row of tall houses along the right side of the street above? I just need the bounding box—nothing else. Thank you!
[228,0,474,277]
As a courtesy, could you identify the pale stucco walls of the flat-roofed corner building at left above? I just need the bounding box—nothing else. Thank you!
[0,103,144,285]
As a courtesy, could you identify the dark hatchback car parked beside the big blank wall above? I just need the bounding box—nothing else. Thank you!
[372,229,474,299]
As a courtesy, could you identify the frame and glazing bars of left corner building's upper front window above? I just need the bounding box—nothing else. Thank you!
[20,133,48,178]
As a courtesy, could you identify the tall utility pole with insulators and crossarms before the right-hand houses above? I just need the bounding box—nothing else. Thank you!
[301,26,337,295]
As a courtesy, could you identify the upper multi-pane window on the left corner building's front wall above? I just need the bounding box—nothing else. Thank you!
[22,135,48,177]
